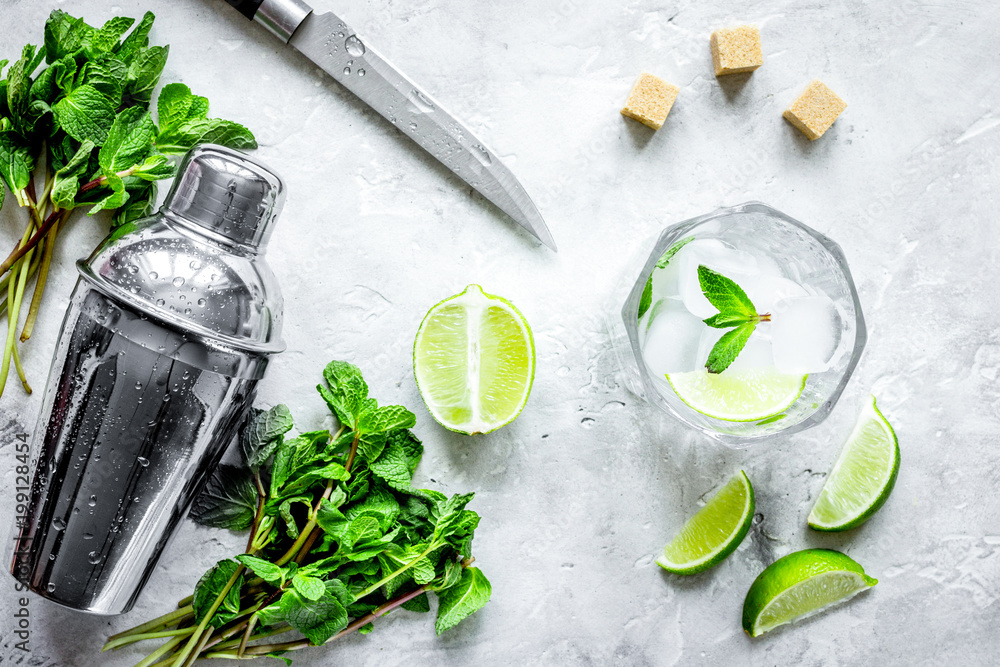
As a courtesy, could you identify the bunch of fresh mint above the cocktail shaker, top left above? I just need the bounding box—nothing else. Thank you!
[0,10,257,394]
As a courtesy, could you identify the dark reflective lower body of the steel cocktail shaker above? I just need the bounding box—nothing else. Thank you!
[13,279,267,614]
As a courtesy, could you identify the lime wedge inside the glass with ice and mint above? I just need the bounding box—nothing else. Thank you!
[667,367,808,422]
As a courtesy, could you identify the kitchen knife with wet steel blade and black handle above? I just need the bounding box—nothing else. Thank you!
[226,0,556,250]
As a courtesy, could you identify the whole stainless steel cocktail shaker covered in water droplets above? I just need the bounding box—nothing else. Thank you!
[11,145,284,614]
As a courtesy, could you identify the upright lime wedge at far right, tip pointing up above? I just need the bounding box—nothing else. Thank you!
[809,396,899,531]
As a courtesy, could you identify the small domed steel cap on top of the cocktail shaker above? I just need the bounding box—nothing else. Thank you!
[164,144,285,248]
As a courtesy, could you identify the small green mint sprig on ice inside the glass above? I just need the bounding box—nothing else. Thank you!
[698,264,771,373]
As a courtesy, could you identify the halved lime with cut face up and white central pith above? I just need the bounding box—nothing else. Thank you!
[413,285,535,435]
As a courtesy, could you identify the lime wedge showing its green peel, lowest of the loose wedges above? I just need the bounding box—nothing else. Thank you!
[743,549,878,637]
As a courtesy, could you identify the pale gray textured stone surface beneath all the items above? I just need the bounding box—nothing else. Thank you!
[0,0,1000,667]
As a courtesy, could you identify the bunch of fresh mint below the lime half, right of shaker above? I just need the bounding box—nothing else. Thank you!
[104,361,491,667]
